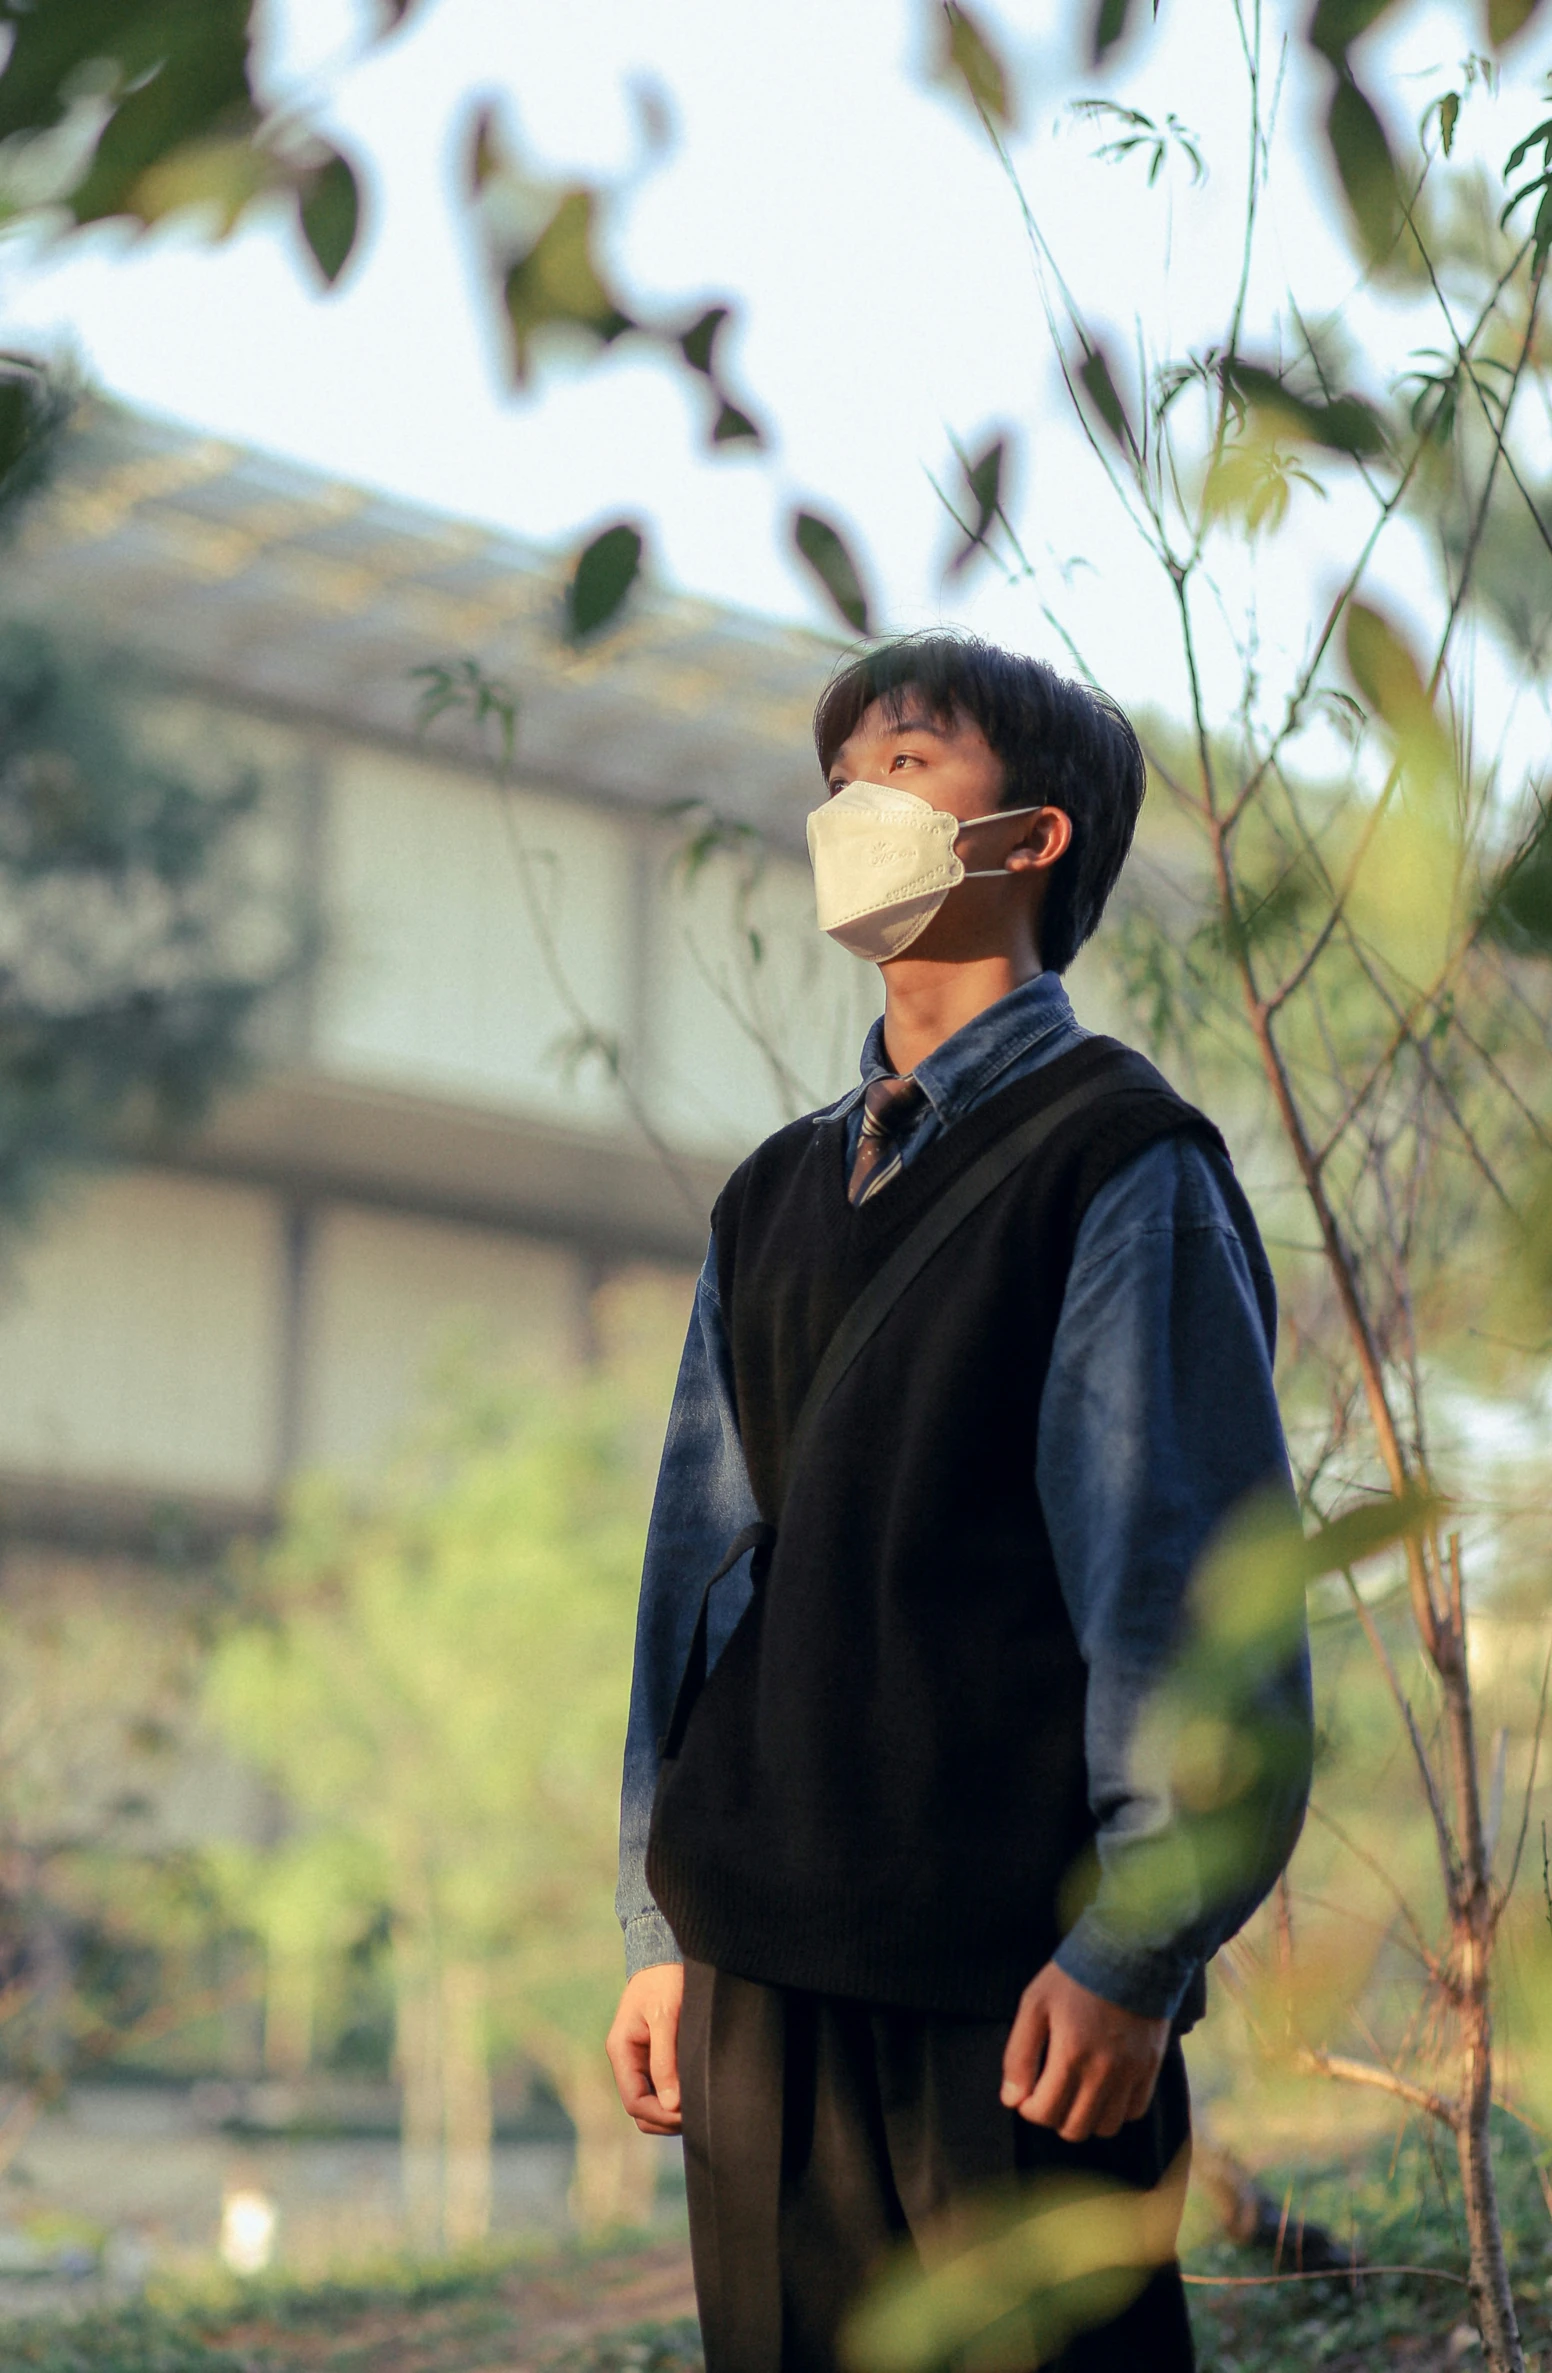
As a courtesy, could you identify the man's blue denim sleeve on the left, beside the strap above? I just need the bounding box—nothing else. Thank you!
[615,1243,759,1977]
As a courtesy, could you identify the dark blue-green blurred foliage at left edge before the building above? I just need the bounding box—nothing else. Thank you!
[0,624,311,1215]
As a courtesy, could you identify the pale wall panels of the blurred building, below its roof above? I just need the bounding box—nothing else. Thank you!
[0,693,876,1521]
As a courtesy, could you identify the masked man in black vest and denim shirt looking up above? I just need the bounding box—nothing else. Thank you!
[608,636,1310,2373]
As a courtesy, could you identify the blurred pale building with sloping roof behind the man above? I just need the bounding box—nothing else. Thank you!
[0,406,873,1559]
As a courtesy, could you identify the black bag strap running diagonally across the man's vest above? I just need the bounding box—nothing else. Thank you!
[660,1065,1115,1761]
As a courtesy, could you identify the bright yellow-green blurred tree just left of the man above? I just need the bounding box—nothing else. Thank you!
[209,1279,683,2226]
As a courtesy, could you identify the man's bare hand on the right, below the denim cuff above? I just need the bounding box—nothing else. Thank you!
[1001,1960,1170,2143]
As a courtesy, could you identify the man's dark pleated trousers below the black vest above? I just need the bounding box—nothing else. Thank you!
[679,1962,1196,2373]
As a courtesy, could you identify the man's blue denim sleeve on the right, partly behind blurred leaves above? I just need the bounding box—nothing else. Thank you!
[1037,1137,1312,2017]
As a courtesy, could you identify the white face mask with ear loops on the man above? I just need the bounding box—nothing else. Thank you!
[809,783,1035,963]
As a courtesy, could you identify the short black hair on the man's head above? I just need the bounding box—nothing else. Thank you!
[814,631,1146,973]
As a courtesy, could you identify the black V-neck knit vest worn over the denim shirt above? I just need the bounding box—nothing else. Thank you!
[648,1039,1222,2017]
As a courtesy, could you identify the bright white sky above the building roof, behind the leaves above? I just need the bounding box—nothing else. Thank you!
[0,0,1552,740]
